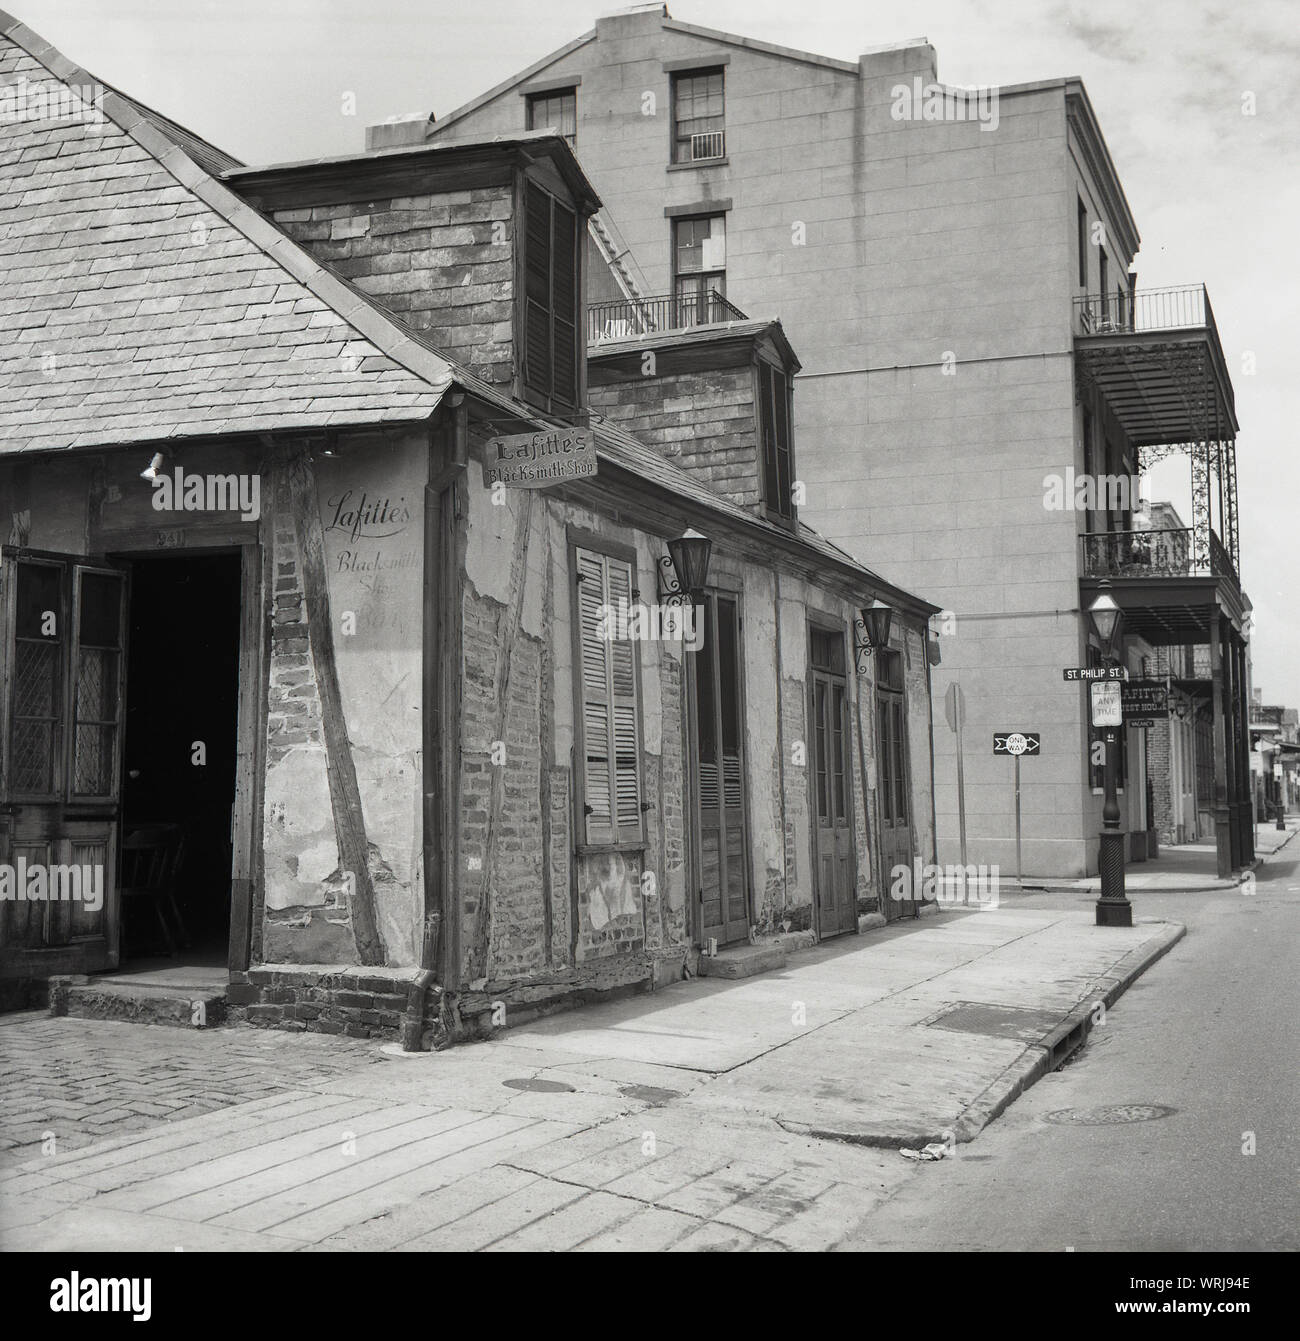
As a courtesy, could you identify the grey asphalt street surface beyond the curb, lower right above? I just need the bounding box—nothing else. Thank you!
[841,848,1300,1252]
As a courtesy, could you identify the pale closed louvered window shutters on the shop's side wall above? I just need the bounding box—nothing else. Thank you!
[574,548,643,843]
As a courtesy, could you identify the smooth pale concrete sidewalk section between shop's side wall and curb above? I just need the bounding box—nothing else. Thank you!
[484,908,1182,1145]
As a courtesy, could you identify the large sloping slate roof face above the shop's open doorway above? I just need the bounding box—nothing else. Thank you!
[0,12,452,453]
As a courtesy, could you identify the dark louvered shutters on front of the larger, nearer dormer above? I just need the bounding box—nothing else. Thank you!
[523,181,580,409]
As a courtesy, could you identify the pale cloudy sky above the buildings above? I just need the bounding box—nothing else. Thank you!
[12,0,1300,707]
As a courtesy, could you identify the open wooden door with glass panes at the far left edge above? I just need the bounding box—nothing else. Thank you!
[0,546,126,978]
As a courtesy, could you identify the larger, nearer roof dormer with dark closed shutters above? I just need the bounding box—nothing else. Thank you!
[225,131,600,418]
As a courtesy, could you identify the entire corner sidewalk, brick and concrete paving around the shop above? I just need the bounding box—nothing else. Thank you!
[0,908,1182,1251]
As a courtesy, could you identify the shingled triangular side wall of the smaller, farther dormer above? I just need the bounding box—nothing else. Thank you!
[588,367,762,507]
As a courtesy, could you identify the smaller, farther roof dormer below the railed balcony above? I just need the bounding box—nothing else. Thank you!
[588,316,800,530]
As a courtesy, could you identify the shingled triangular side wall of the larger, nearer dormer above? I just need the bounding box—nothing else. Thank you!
[272,186,515,384]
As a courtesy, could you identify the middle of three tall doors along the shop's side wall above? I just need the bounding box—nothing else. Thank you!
[810,629,857,939]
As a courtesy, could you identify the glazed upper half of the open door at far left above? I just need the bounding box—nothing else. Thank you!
[4,558,125,801]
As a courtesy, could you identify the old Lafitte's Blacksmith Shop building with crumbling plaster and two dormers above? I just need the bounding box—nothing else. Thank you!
[0,17,936,1046]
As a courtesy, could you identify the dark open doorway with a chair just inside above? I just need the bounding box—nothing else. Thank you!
[119,554,240,970]
